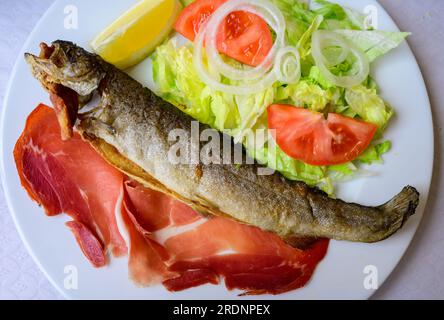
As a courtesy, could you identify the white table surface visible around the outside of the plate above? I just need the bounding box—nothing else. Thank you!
[0,0,444,299]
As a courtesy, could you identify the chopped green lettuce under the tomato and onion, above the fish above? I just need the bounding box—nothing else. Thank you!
[152,0,408,194]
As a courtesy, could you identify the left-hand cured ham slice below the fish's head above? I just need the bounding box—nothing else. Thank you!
[14,104,127,260]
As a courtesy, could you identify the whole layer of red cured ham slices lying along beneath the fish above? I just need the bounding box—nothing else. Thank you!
[14,105,328,294]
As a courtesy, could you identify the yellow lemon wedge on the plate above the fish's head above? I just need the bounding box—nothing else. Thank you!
[91,0,182,69]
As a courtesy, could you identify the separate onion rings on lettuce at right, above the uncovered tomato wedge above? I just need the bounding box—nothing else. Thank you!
[311,30,370,88]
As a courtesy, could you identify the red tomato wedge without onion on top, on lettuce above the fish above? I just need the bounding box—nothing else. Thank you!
[267,104,378,166]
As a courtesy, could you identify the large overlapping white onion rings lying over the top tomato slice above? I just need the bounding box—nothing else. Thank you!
[193,0,300,95]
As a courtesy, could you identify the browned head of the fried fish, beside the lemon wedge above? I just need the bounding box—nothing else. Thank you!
[25,40,105,97]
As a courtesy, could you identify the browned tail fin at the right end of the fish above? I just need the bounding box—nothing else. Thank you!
[380,186,419,228]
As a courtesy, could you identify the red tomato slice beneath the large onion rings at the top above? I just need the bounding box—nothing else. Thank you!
[174,0,273,66]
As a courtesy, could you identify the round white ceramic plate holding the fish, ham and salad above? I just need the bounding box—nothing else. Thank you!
[1,0,434,299]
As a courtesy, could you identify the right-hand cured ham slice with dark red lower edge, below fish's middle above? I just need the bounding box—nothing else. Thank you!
[123,181,328,294]
